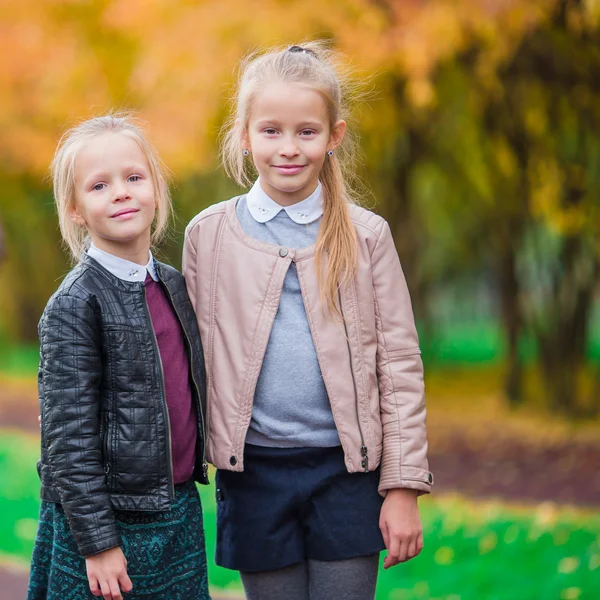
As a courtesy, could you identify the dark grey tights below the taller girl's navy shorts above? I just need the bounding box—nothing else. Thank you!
[241,553,379,600]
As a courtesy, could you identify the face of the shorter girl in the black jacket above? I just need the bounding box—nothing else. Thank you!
[71,133,156,264]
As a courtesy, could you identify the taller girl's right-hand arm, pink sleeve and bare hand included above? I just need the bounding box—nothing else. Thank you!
[372,221,433,568]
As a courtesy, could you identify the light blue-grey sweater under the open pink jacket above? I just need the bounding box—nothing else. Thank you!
[236,196,340,448]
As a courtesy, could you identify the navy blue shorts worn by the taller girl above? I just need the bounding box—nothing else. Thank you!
[216,444,385,572]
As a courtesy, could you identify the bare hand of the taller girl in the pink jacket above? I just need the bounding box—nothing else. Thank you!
[379,489,423,569]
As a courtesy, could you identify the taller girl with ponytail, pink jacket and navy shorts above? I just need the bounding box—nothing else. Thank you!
[183,43,432,600]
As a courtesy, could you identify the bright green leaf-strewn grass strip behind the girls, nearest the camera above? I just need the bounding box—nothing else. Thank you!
[0,431,600,600]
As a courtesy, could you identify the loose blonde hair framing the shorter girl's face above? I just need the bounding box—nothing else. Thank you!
[51,113,172,262]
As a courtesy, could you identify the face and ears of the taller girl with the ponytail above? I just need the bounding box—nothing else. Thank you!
[242,83,346,206]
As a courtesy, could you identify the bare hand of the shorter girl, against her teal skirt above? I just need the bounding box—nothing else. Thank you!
[85,546,133,600]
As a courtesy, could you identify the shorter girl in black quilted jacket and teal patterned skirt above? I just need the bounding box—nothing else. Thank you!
[28,115,209,600]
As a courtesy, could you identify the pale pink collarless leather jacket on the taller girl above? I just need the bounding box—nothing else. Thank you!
[183,198,433,494]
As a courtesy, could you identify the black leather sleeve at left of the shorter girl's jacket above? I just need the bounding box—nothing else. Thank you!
[39,296,120,557]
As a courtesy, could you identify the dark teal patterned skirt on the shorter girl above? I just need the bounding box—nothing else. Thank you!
[27,482,210,600]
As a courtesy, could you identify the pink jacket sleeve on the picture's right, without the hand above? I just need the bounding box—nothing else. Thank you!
[371,221,433,494]
